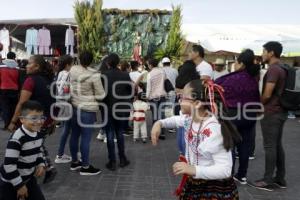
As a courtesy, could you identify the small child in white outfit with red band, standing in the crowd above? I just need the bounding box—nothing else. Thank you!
[132,93,149,143]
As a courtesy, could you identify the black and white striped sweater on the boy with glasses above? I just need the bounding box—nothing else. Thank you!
[0,126,45,189]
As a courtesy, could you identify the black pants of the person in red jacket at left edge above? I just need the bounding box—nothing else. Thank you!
[0,90,18,128]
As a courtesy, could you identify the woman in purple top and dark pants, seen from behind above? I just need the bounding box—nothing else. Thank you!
[216,49,260,184]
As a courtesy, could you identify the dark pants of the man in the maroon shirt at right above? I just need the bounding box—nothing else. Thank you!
[261,113,287,183]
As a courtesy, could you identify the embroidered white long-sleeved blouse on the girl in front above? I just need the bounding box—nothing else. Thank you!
[160,115,232,180]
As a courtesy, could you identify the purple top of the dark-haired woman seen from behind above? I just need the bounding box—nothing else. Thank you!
[215,70,260,108]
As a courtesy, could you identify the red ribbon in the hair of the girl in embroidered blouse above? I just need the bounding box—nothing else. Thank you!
[204,80,227,114]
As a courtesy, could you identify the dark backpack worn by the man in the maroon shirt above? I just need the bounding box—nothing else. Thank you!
[279,64,300,111]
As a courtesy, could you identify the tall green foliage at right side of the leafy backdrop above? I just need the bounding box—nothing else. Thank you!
[154,6,184,62]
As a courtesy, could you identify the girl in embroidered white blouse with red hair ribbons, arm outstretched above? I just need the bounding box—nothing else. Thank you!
[151,79,239,200]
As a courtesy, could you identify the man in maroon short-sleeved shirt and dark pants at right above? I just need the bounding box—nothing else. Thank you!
[252,42,287,191]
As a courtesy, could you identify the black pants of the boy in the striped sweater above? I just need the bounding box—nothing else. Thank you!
[0,177,45,200]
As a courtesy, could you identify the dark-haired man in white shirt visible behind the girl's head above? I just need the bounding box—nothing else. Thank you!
[189,45,213,80]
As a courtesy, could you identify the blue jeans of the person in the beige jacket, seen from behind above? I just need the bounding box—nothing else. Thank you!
[70,108,96,167]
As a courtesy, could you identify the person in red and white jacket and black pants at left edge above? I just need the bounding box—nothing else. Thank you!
[0,52,19,130]
